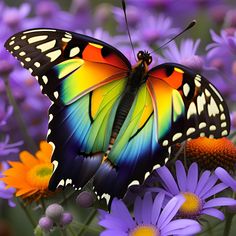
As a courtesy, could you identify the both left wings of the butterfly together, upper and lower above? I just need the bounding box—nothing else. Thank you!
[5,29,131,194]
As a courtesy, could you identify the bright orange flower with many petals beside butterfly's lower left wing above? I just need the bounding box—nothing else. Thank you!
[2,141,53,201]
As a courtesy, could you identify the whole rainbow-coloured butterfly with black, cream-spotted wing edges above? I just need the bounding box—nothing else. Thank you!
[5,28,230,200]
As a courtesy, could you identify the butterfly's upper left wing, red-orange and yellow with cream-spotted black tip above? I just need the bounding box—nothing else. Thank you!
[5,28,131,104]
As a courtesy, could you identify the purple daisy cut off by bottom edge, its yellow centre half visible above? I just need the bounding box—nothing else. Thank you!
[99,193,201,236]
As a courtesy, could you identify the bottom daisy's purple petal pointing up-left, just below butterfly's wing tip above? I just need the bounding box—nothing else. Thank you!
[111,198,135,227]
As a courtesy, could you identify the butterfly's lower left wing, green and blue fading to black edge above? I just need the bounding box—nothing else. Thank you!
[48,79,126,189]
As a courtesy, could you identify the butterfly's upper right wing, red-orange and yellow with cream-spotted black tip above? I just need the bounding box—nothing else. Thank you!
[147,63,230,146]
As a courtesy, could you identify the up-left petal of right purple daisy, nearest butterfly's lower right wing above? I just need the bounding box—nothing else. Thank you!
[157,166,179,195]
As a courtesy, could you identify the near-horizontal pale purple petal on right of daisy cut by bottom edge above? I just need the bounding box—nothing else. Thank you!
[161,219,201,235]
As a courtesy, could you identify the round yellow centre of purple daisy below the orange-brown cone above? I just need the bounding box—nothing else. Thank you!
[179,192,202,216]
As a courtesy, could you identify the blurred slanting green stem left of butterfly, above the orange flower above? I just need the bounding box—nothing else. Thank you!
[4,78,37,153]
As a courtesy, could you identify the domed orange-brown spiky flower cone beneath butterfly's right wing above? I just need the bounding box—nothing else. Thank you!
[178,137,236,171]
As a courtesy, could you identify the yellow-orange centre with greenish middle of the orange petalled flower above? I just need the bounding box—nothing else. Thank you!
[27,163,53,189]
